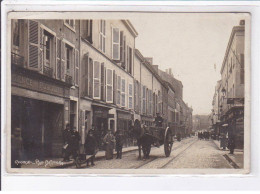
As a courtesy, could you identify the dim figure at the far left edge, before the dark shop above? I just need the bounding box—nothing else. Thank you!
[11,127,23,168]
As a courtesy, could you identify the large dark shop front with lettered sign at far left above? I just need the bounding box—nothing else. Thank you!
[11,70,69,160]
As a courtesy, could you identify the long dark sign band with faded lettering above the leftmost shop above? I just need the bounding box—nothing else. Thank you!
[11,73,64,96]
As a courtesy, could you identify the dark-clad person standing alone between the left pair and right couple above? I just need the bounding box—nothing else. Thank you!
[85,130,98,166]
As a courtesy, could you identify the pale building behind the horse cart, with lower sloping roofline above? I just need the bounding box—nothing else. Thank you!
[134,49,168,127]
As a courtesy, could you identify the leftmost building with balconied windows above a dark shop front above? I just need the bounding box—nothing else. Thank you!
[11,20,79,159]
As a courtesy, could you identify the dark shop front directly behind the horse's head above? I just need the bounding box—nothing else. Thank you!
[117,110,135,147]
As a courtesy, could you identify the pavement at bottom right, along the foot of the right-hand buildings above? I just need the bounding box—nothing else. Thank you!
[213,140,244,168]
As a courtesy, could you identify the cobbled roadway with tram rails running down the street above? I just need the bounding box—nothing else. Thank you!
[70,137,232,169]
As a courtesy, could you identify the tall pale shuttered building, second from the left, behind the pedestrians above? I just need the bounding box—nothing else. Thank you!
[80,20,138,146]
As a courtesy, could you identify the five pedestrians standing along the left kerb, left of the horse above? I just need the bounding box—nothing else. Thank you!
[63,124,124,166]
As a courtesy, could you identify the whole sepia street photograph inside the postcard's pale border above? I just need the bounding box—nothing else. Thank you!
[7,13,248,173]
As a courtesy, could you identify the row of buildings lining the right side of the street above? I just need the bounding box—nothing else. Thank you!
[212,20,245,148]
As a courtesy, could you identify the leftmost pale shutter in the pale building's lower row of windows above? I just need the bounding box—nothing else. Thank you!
[93,61,101,99]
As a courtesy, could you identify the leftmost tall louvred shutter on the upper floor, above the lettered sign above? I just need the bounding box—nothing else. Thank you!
[28,20,41,71]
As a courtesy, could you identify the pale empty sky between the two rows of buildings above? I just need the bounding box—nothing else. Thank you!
[130,13,245,115]
